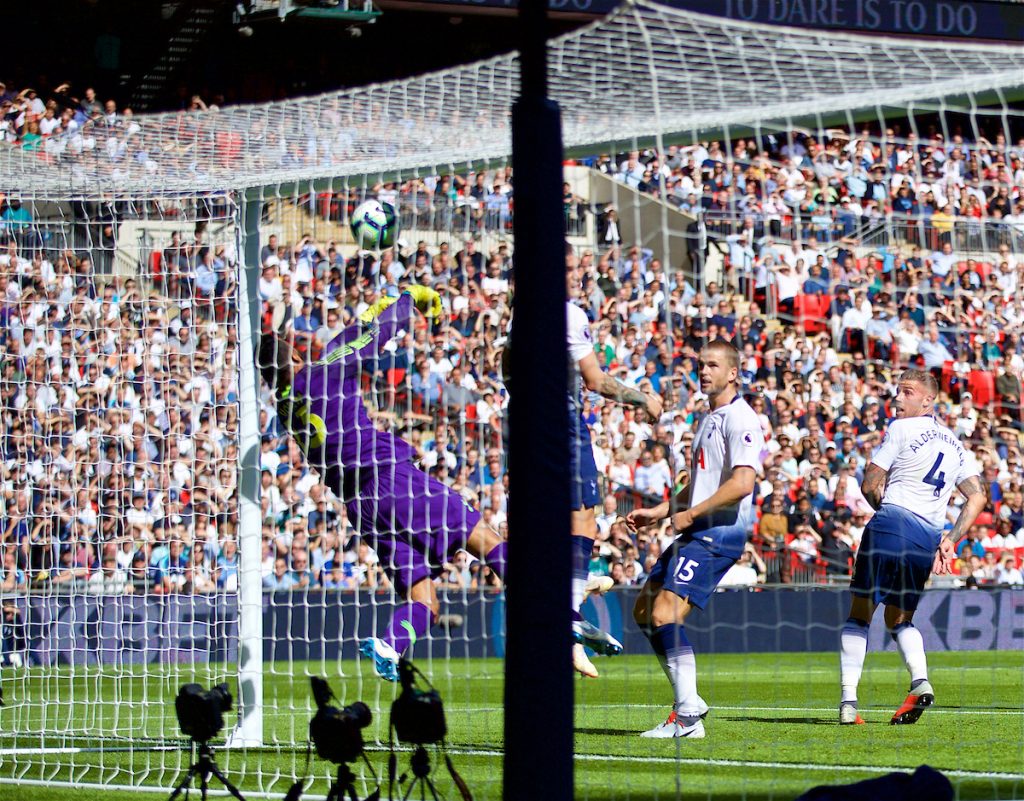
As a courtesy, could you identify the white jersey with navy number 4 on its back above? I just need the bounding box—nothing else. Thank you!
[871,415,978,531]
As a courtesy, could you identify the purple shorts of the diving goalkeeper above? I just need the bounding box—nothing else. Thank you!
[345,462,480,592]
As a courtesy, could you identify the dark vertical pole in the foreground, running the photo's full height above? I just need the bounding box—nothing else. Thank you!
[503,0,573,801]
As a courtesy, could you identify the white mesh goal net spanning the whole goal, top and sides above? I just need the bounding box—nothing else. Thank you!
[0,2,1024,798]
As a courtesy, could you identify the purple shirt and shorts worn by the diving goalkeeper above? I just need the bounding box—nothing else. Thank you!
[278,294,480,593]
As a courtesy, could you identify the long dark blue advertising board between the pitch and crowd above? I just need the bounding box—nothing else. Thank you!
[3,588,1024,666]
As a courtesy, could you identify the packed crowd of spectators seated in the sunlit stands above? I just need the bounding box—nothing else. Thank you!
[0,86,1024,606]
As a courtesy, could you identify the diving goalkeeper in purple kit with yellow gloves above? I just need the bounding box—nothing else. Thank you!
[259,286,506,681]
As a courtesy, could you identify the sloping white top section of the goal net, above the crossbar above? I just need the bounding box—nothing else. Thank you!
[0,0,1024,199]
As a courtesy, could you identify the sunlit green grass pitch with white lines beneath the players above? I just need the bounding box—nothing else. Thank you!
[0,651,1024,801]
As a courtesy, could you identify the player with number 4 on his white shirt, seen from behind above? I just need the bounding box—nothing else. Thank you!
[839,370,987,724]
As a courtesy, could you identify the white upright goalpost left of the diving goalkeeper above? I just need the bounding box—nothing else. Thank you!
[228,196,263,748]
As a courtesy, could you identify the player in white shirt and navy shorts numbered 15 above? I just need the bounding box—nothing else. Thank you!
[627,340,765,737]
